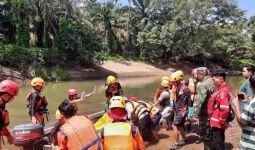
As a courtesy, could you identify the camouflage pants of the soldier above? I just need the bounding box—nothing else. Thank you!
[198,119,212,150]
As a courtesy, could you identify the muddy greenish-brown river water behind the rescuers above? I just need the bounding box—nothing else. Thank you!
[2,76,244,149]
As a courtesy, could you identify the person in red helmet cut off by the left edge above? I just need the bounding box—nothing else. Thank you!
[0,80,19,149]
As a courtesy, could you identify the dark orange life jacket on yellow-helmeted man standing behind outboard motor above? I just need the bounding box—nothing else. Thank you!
[26,93,48,114]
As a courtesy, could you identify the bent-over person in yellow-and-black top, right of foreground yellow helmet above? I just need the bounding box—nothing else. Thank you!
[126,97,154,141]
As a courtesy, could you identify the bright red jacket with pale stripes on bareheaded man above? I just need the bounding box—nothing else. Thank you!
[208,82,231,129]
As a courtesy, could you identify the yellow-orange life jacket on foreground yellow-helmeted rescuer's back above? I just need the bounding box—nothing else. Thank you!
[101,122,136,150]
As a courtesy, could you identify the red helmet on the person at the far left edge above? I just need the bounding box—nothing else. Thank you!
[0,80,19,96]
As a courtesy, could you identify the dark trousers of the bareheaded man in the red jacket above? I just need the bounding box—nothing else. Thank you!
[212,127,225,150]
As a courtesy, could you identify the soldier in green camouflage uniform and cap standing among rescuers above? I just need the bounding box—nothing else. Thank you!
[192,67,216,150]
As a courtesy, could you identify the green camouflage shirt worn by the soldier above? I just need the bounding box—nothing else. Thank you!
[192,76,216,119]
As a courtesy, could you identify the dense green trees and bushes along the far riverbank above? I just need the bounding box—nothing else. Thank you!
[0,0,255,80]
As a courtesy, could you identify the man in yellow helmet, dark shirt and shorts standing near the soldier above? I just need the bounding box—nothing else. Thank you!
[169,72,190,149]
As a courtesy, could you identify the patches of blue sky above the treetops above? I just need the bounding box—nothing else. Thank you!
[99,0,255,18]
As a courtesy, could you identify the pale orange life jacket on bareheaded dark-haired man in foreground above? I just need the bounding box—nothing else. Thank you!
[60,115,101,150]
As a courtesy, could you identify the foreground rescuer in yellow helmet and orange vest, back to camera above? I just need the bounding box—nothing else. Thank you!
[100,96,145,150]
